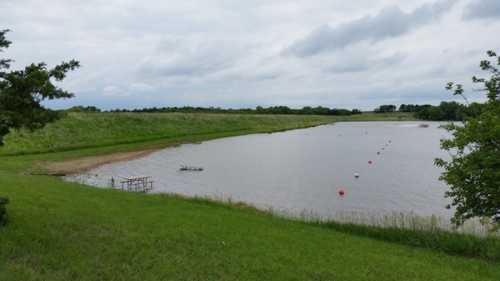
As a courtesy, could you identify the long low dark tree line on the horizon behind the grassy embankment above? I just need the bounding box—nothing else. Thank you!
[101,106,362,115]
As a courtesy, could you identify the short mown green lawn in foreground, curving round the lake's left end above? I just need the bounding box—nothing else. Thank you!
[0,112,500,281]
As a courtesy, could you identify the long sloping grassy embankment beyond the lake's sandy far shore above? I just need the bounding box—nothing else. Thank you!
[0,113,335,155]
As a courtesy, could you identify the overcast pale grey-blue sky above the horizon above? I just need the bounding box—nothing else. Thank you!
[0,0,500,109]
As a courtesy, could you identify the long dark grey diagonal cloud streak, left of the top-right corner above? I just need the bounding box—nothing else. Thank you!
[285,0,456,57]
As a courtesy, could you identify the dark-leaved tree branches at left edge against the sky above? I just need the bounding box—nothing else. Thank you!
[0,30,80,145]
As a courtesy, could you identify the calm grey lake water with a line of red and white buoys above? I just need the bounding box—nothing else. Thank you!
[67,122,452,218]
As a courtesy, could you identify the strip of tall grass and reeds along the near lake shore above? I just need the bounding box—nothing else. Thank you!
[176,190,500,262]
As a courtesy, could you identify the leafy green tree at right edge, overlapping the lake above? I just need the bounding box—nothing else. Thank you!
[436,51,500,226]
